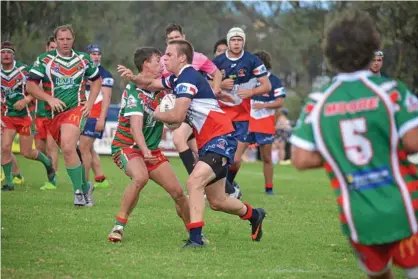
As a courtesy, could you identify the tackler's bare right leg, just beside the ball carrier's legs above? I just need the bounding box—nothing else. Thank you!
[149,161,190,228]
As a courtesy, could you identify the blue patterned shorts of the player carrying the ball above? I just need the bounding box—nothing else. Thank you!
[199,134,238,165]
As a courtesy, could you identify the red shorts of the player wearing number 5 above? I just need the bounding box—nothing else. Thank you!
[351,234,418,275]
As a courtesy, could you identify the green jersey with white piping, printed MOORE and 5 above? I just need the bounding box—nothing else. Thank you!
[305,72,418,244]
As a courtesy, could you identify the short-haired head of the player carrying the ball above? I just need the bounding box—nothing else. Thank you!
[164,40,193,74]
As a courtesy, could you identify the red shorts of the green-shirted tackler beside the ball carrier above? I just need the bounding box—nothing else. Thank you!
[112,150,168,173]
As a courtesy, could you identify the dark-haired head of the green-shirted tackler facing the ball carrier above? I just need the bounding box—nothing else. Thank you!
[134,47,163,78]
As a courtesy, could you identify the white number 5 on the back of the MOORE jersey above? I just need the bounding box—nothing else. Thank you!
[340,118,373,166]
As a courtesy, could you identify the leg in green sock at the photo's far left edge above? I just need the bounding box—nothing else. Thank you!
[1,128,16,191]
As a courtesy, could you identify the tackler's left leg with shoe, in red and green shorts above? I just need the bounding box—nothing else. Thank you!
[108,151,149,242]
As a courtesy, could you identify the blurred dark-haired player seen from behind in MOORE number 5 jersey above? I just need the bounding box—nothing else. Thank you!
[290,10,418,278]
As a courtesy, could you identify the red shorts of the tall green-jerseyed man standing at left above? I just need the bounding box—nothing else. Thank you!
[47,106,87,146]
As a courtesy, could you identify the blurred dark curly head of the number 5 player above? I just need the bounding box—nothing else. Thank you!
[323,10,380,73]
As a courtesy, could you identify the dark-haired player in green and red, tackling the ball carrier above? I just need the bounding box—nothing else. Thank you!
[108,47,190,242]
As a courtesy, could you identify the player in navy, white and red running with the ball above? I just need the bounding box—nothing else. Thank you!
[118,40,266,248]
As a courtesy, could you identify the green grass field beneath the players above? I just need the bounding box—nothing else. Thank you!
[1,157,404,278]
